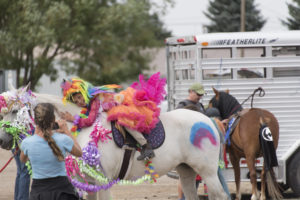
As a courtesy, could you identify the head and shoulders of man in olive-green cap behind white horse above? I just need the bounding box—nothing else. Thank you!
[176,83,205,113]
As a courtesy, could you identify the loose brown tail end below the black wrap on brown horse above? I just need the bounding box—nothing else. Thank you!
[266,169,282,199]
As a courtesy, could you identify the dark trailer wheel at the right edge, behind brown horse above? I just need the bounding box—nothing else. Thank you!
[287,152,300,197]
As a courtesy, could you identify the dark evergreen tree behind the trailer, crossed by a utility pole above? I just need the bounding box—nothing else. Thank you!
[204,0,266,32]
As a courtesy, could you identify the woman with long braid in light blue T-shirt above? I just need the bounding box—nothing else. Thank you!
[20,103,82,200]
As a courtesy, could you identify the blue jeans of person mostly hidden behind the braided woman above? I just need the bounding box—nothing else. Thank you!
[13,150,30,200]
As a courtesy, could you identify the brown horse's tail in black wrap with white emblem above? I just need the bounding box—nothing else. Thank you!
[259,117,282,199]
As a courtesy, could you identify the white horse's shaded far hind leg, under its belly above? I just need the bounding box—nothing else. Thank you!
[176,164,199,200]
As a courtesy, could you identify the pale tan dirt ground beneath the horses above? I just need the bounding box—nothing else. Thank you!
[0,149,254,200]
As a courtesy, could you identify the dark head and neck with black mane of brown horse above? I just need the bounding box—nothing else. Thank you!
[210,91,243,119]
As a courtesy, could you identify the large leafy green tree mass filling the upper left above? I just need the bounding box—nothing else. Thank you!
[0,0,170,88]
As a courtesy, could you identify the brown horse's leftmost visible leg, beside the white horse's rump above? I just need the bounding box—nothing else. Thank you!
[229,148,241,200]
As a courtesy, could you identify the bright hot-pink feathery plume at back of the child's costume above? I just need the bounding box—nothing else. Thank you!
[130,72,166,105]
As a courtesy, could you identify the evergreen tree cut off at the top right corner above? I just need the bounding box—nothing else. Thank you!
[282,0,300,30]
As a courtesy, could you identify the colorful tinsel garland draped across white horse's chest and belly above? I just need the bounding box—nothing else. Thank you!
[65,116,159,195]
